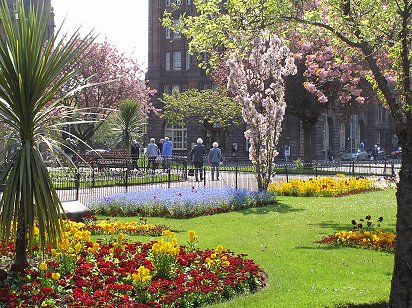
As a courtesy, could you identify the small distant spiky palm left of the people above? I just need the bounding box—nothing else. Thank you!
[111,99,146,169]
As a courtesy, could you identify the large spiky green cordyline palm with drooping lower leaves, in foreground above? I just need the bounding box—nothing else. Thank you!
[0,0,94,267]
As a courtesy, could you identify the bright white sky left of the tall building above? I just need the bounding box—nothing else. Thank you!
[51,0,150,69]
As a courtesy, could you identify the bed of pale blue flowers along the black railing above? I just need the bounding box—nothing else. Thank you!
[90,188,276,218]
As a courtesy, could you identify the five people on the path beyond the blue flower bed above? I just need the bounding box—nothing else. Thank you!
[130,137,222,182]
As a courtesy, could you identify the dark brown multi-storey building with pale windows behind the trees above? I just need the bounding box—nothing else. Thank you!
[146,0,397,160]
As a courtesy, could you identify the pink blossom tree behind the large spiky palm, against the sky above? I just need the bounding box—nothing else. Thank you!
[64,41,153,150]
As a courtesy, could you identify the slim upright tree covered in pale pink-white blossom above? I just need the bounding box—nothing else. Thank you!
[228,31,296,190]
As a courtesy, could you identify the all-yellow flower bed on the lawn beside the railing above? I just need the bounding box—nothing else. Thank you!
[268,175,379,197]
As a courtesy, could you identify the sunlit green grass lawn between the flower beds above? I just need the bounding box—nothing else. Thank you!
[104,190,396,308]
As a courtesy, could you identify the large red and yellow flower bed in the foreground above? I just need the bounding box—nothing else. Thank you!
[0,227,266,307]
